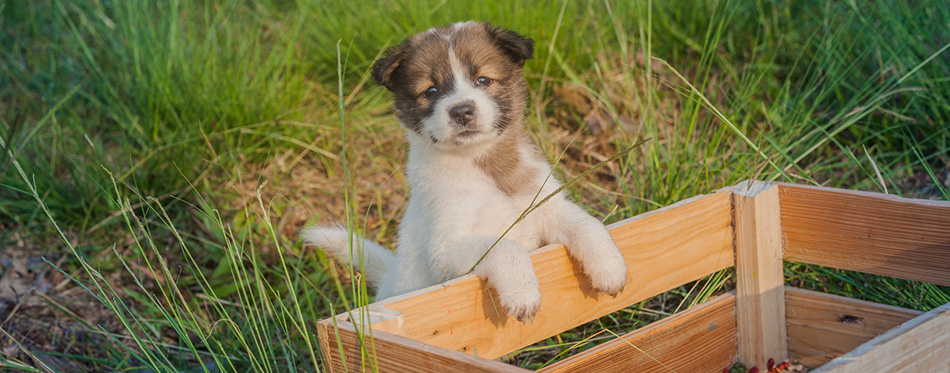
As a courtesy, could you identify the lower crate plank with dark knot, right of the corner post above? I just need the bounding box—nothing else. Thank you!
[785,287,923,367]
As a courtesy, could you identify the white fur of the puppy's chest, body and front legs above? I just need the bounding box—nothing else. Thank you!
[390,135,627,319]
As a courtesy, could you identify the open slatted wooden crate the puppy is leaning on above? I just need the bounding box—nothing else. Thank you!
[318,182,950,373]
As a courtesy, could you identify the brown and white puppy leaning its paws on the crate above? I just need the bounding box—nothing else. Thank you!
[302,21,627,322]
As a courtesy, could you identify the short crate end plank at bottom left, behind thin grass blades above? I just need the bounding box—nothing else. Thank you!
[317,320,529,373]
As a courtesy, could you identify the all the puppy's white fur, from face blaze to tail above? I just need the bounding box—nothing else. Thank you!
[303,24,627,321]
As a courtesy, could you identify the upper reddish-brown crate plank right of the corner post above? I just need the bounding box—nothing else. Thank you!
[780,184,950,286]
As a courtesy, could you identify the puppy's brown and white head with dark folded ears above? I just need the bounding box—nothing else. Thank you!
[373,22,534,149]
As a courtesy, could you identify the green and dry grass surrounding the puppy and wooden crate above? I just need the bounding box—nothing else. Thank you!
[0,0,950,371]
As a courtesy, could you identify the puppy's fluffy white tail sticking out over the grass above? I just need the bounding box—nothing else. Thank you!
[300,226,396,286]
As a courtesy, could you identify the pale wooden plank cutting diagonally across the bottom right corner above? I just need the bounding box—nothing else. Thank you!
[815,303,950,373]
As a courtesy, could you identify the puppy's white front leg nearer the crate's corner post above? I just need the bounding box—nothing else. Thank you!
[544,198,627,295]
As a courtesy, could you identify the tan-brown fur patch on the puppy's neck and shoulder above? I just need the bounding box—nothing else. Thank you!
[475,127,540,196]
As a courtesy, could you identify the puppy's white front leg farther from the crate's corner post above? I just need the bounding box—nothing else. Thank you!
[437,235,541,323]
